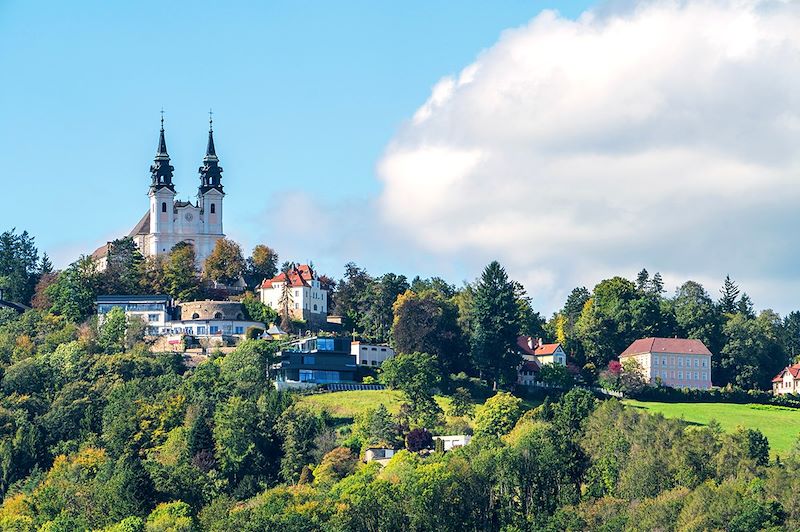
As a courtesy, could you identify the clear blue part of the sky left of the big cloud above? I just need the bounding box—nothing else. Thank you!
[0,0,583,262]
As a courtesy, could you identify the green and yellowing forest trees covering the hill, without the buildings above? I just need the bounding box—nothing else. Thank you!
[0,227,800,532]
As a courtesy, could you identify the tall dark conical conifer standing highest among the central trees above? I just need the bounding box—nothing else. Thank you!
[471,261,521,389]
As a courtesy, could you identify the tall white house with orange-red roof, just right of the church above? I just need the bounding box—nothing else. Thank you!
[256,264,328,324]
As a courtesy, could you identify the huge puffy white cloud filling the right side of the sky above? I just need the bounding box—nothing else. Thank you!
[378,0,800,310]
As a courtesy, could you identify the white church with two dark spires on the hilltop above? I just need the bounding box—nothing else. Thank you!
[92,116,230,270]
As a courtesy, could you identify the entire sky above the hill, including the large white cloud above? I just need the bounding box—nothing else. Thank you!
[0,0,800,314]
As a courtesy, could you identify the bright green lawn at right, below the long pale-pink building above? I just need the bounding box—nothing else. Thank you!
[624,400,800,454]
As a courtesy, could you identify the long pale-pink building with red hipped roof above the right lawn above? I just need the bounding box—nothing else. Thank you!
[619,338,711,389]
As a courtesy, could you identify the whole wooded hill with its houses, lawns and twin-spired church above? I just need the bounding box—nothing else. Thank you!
[0,121,800,532]
